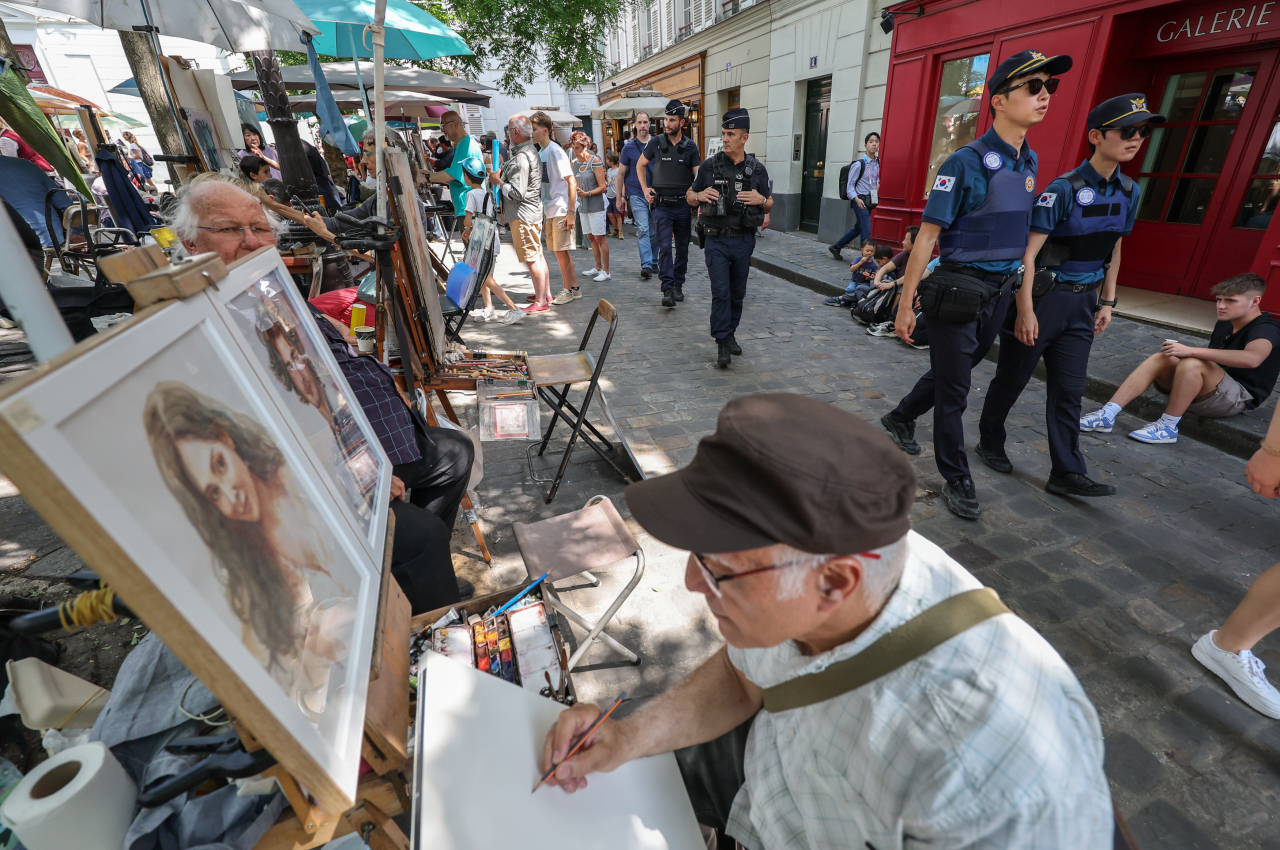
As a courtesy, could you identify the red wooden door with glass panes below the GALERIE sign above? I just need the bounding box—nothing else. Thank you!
[1121,51,1280,297]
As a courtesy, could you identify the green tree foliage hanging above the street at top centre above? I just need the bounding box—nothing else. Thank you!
[246,0,624,97]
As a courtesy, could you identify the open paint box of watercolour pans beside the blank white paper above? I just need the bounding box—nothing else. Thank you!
[410,581,577,702]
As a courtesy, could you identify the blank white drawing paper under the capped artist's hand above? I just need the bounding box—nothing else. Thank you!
[413,652,707,850]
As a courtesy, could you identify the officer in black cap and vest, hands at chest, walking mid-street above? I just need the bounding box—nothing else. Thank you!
[686,109,773,367]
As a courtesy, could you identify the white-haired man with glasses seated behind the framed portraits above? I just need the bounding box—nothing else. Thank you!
[170,175,475,606]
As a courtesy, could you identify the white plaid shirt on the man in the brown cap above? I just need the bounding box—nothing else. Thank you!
[728,531,1114,850]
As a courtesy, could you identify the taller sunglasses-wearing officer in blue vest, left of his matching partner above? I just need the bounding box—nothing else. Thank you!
[881,50,1071,520]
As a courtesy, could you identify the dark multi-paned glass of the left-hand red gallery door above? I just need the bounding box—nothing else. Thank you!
[1138,67,1254,227]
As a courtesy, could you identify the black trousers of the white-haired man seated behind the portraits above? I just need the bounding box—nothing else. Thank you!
[392,428,475,614]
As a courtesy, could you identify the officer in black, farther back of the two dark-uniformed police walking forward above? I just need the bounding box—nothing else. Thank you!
[636,100,701,307]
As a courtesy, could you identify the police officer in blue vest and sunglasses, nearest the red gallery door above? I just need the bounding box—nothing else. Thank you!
[978,93,1165,497]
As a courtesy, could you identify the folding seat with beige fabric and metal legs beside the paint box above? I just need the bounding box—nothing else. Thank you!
[511,495,644,670]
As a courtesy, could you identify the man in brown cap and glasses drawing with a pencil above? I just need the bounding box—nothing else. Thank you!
[543,394,1114,850]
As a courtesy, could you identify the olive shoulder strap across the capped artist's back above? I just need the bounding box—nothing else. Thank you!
[764,588,1012,713]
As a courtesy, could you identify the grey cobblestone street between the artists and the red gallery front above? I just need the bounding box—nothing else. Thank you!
[456,229,1280,850]
